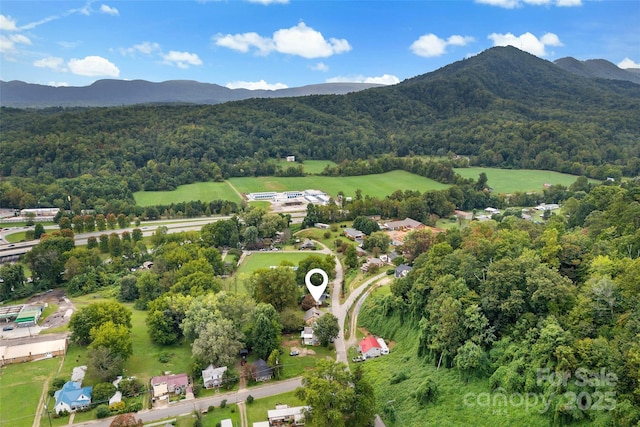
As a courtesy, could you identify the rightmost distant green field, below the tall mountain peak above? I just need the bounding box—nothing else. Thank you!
[455,168,599,193]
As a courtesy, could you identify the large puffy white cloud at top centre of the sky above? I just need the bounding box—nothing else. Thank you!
[213,22,351,59]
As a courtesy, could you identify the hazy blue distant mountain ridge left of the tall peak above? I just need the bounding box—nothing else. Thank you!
[0,79,382,108]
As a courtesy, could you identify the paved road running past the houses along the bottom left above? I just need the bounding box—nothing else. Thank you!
[73,377,302,427]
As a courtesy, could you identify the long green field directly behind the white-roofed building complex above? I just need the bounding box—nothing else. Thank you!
[229,170,449,197]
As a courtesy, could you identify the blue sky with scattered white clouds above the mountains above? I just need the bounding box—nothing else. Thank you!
[0,0,640,89]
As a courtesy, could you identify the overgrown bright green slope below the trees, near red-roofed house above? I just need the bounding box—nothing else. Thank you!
[359,312,550,427]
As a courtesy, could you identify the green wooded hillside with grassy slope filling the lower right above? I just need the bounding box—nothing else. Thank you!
[361,181,640,426]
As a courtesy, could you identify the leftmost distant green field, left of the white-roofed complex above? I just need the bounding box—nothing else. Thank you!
[133,182,240,206]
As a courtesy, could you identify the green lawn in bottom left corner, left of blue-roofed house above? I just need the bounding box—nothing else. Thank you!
[0,357,60,427]
